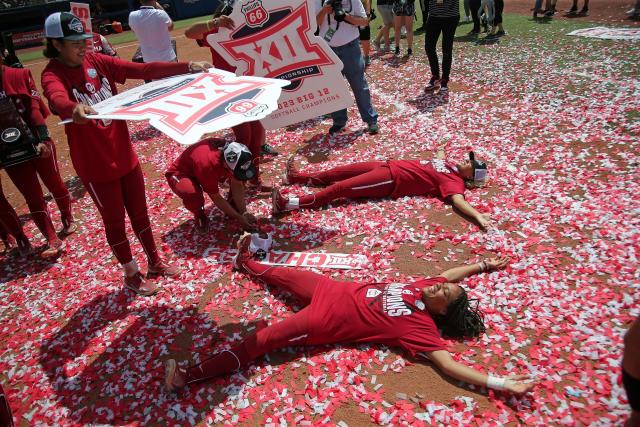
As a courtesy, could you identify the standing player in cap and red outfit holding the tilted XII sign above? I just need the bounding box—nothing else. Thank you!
[42,12,210,295]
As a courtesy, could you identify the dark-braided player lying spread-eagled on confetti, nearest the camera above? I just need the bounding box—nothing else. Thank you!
[165,235,534,393]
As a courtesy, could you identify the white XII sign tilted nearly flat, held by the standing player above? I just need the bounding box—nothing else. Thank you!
[62,68,289,145]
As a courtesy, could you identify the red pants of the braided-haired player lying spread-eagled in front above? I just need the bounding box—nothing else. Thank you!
[185,260,340,383]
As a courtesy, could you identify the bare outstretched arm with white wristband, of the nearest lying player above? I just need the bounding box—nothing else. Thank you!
[426,350,535,394]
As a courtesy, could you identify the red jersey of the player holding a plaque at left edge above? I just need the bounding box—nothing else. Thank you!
[0,65,49,127]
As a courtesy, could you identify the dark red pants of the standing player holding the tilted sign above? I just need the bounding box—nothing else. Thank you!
[83,164,160,264]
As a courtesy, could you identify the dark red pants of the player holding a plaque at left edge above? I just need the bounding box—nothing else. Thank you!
[6,141,72,242]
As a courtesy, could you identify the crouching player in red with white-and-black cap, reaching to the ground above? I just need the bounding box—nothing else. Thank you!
[165,138,257,234]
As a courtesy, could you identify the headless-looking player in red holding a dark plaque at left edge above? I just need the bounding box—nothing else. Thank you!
[0,59,76,258]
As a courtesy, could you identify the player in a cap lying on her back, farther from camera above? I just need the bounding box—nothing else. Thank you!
[271,152,491,229]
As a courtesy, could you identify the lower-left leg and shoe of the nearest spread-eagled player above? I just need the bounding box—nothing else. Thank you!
[176,308,310,389]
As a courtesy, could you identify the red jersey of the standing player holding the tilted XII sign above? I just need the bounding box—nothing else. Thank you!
[42,52,189,182]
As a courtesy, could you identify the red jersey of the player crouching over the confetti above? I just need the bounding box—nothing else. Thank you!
[165,139,231,194]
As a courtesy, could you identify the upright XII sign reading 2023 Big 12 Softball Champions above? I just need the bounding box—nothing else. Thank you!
[207,0,352,129]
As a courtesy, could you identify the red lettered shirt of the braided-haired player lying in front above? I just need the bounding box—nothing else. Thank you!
[307,277,446,355]
